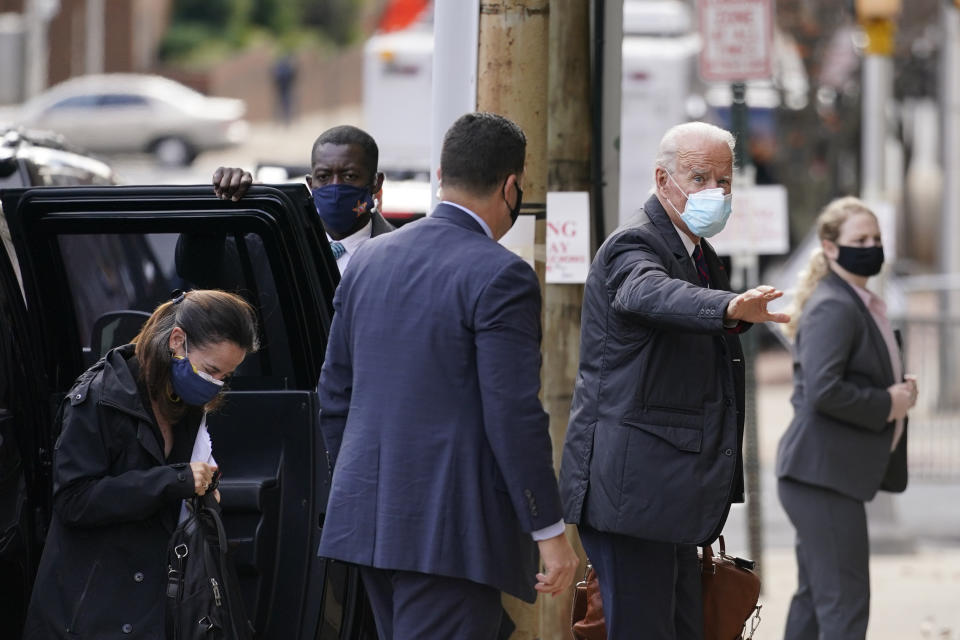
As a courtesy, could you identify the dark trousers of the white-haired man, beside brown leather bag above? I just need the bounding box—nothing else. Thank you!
[580,525,703,640]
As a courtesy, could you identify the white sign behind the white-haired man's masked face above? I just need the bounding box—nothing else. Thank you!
[710,184,790,256]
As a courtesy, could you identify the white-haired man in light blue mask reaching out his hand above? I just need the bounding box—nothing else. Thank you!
[560,122,788,640]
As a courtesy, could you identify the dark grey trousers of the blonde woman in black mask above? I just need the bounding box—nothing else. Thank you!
[777,478,870,640]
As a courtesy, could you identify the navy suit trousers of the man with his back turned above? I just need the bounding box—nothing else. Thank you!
[360,567,503,640]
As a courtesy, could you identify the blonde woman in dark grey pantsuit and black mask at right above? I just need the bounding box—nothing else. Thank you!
[777,197,917,640]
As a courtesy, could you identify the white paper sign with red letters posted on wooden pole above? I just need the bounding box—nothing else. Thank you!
[546,191,590,284]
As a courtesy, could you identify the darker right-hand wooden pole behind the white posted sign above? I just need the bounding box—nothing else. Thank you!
[540,0,593,640]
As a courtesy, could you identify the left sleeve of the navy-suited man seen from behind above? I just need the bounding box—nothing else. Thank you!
[317,284,353,471]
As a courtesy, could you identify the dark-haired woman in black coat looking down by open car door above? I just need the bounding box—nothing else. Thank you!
[24,290,258,639]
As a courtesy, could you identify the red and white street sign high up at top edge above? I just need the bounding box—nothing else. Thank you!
[698,0,773,82]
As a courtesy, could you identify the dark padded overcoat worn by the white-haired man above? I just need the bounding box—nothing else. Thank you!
[560,196,749,544]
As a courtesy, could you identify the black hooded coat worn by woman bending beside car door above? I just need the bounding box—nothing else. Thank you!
[24,345,196,640]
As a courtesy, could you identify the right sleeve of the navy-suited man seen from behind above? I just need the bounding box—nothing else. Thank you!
[475,260,562,532]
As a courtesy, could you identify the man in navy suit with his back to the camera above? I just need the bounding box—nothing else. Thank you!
[319,113,577,640]
